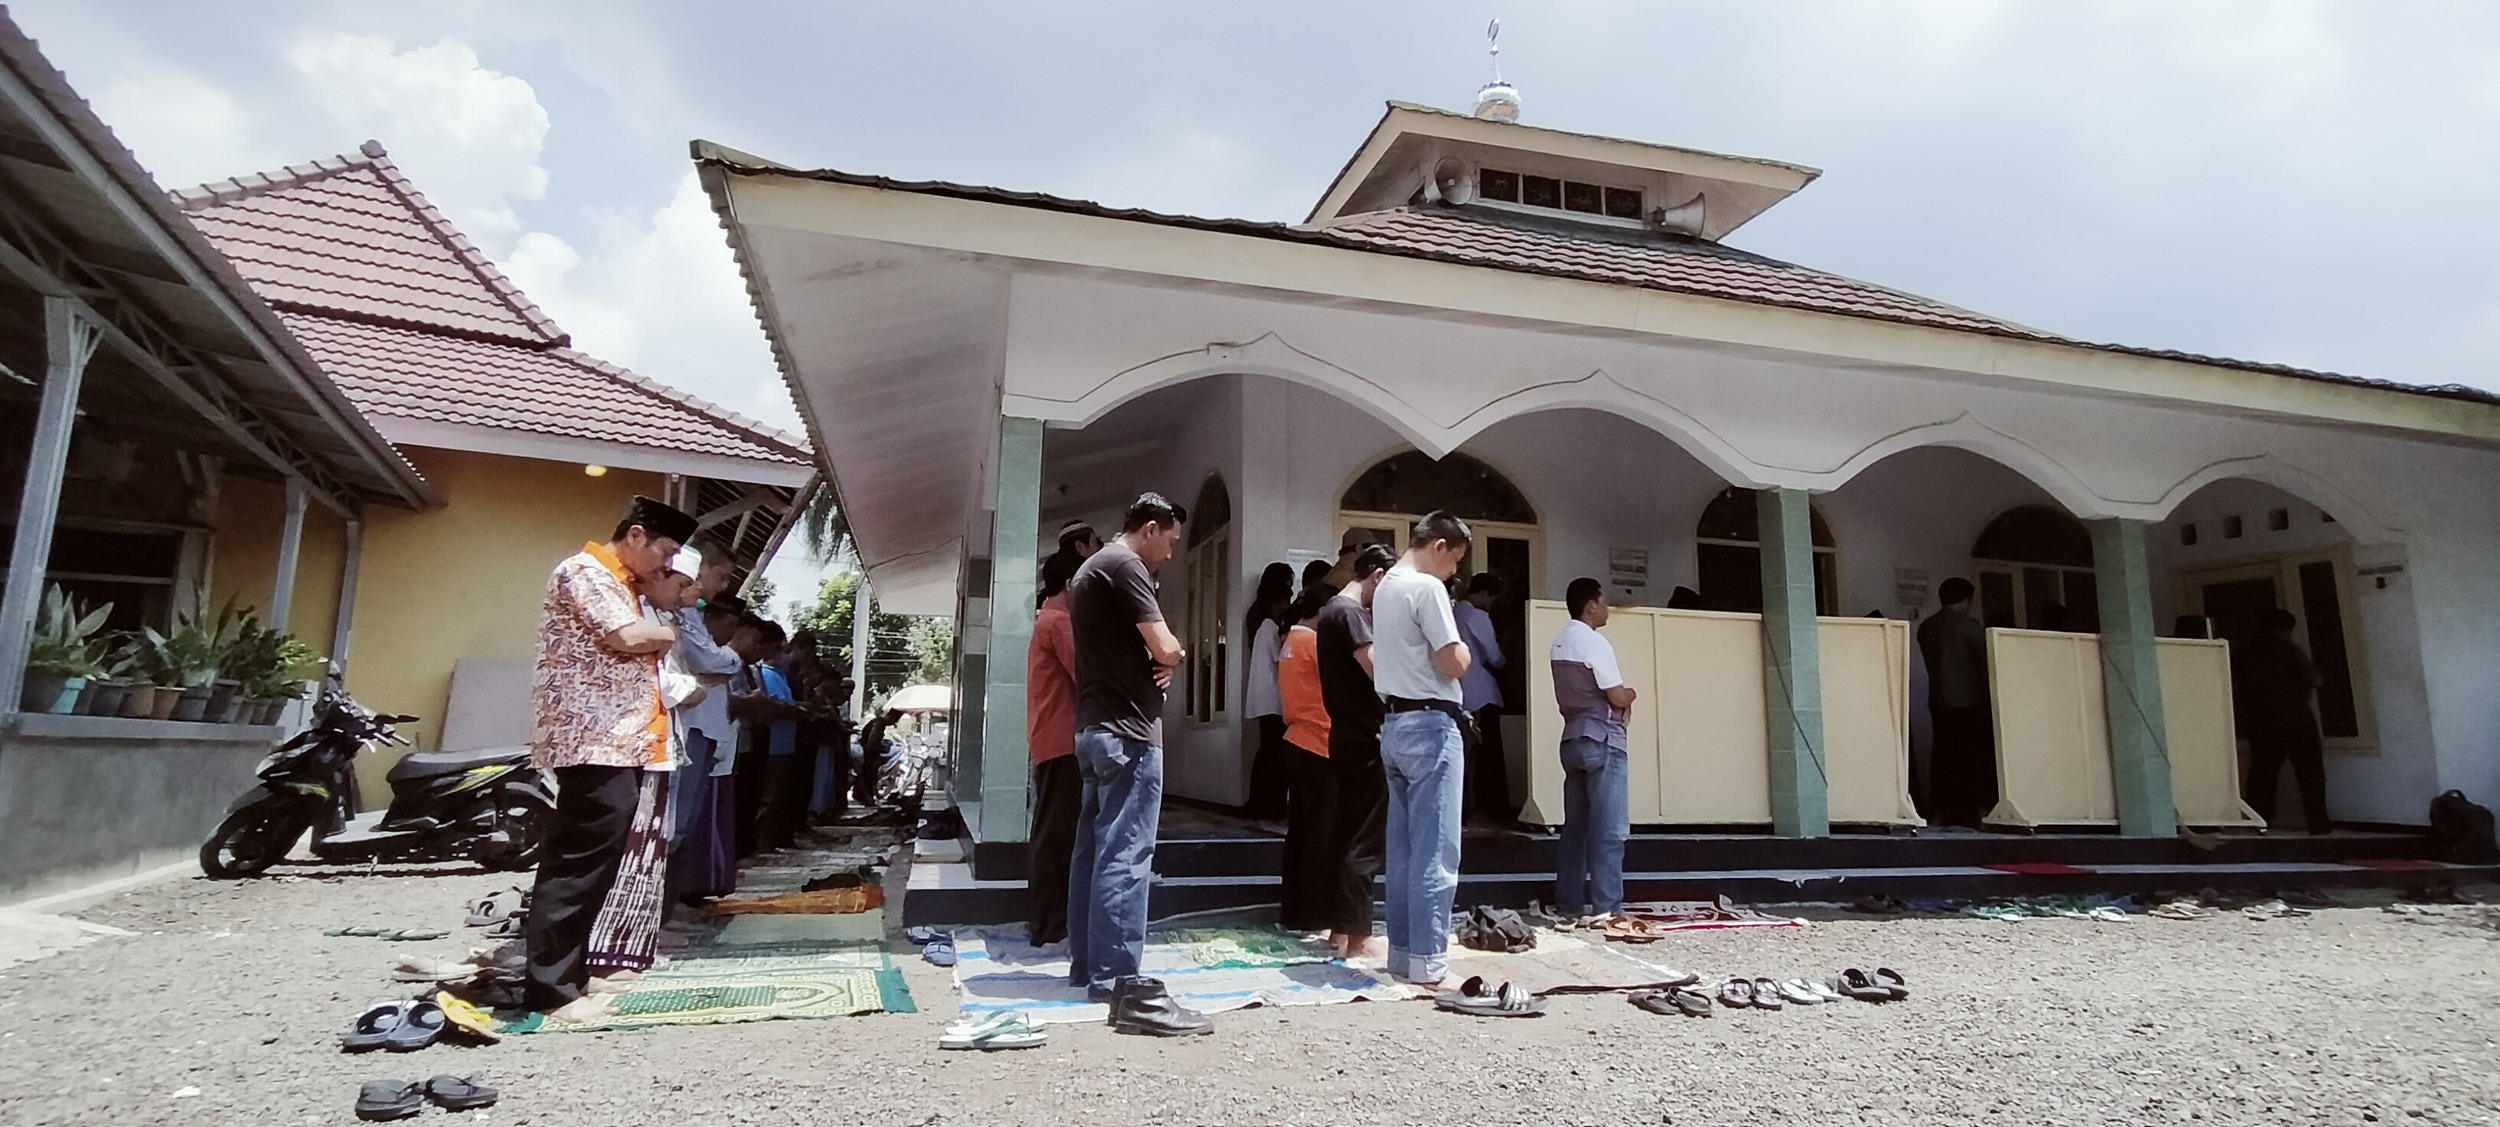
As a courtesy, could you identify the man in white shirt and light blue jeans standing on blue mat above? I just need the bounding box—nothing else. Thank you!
[1373,512,1470,990]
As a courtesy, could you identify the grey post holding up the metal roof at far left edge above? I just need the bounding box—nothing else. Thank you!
[0,297,95,715]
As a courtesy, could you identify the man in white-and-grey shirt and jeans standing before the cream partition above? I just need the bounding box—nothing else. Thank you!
[1553,577,1635,915]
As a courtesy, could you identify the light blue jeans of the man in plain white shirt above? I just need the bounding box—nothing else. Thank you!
[1380,710,1468,982]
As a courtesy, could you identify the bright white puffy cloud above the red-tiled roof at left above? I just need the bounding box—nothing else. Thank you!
[288,32,548,252]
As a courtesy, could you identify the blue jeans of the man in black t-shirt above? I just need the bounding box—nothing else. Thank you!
[1068,727,1163,1002]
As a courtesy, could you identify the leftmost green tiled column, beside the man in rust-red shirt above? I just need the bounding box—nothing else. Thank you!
[980,417,1043,845]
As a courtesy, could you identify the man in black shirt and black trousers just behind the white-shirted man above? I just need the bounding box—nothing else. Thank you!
[1313,545,1398,957]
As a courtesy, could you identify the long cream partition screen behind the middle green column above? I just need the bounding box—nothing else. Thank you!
[1520,602,1918,825]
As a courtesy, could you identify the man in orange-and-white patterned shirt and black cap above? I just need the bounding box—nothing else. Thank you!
[525,497,695,1022]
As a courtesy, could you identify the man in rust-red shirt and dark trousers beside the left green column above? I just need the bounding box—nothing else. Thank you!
[1025,552,1090,947]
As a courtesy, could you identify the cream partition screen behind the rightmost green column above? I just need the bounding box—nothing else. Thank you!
[1988,630,2263,825]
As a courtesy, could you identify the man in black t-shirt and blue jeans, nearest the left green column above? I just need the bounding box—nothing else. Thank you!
[1068,492,1213,1037]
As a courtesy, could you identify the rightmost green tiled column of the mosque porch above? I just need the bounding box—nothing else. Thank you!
[2090,520,2178,837]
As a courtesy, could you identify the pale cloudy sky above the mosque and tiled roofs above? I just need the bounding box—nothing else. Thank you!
[8,0,2500,587]
